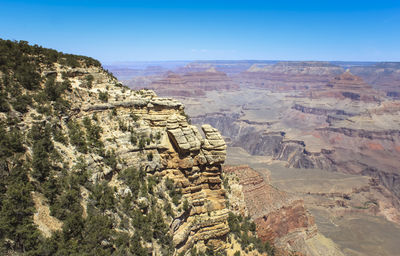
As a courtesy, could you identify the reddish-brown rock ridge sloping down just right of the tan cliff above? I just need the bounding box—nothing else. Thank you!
[224,166,342,255]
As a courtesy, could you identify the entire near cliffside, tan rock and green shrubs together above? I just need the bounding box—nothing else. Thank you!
[0,40,233,255]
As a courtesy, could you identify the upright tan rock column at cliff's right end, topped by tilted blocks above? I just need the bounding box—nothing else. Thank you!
[161,120,229,251]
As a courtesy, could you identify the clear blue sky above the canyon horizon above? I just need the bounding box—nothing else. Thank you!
[0,0,400,63]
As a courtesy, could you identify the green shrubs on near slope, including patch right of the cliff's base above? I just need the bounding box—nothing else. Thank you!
[0,39,276,256]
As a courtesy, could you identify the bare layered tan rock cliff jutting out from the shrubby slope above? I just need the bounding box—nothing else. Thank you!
[65,71,229,252]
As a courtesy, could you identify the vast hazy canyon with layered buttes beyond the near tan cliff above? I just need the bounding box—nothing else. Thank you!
[114,61,400,255]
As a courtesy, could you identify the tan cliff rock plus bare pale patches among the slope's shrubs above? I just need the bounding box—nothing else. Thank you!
[18,63,229,255]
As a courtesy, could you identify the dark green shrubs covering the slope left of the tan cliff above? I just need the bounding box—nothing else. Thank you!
[0,40,177,255]
